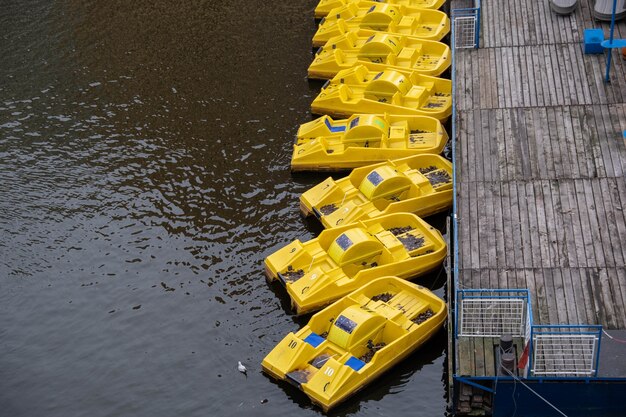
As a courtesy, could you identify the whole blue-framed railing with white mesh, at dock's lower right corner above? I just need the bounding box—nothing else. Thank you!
[529,325,602,377]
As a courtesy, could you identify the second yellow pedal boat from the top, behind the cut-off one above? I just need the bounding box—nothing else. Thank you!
[313,1,450,46]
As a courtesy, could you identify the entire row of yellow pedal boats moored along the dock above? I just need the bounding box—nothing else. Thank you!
[262,0,453,411]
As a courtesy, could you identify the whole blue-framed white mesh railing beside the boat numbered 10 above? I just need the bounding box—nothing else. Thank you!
[456,289,532,338]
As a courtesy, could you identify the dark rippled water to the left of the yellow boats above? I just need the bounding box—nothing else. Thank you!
[0,0,445,417]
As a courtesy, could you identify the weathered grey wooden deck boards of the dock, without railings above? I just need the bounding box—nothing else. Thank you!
[451,0,626,375]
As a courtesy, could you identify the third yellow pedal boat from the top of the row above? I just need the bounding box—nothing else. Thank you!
[309,31,451,78]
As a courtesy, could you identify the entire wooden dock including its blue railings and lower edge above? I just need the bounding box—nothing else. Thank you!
[450,0,626,416]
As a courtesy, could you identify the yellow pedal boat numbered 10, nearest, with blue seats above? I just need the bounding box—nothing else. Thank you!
[262,277,448,411]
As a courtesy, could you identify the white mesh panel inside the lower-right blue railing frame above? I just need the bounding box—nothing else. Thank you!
[531,334,599,377]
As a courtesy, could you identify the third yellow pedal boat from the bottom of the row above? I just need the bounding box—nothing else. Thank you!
[300,154,452,228]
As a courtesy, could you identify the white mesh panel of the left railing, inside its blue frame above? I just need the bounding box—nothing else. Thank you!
[458,297,527,337]
